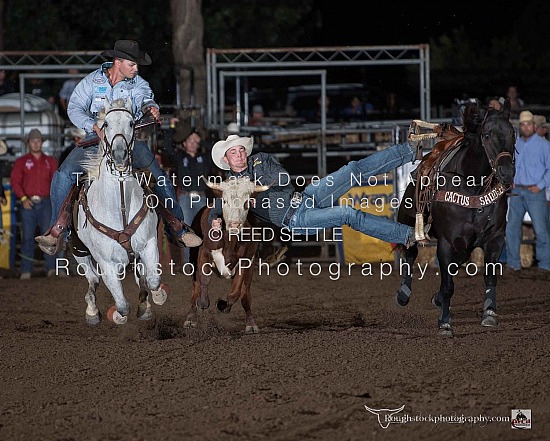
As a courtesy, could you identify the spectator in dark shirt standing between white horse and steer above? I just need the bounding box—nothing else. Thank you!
[164,125,213,263]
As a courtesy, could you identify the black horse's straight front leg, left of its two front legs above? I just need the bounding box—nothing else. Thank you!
[432,241,459,337]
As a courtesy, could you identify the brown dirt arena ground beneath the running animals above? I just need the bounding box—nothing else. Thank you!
[0,258,550,441]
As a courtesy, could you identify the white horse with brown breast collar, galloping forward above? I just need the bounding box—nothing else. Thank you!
[75,99,167,325]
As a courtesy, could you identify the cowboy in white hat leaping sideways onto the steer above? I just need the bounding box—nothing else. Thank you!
[209,135,416,244]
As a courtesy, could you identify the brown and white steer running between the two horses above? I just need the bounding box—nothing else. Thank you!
[184,177,269,334]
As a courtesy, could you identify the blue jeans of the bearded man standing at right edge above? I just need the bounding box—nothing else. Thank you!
[506,187,550,270]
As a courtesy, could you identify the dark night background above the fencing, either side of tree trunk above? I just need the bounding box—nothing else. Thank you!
[3,0,550,111]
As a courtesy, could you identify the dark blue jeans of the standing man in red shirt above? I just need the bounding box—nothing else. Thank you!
[21,199,56,273]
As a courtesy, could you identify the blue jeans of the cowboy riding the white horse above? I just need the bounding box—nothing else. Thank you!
[49,135,184,226]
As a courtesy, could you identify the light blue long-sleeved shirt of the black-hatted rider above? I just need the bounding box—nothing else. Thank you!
[67,62,159,133]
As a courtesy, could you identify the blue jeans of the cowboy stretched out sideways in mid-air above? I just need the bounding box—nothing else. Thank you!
[286,143,416,244]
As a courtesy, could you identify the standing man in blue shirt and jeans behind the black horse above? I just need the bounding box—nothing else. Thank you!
[506,110,550,271]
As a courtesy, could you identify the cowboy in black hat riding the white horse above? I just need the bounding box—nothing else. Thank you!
[36,40,202,255]
